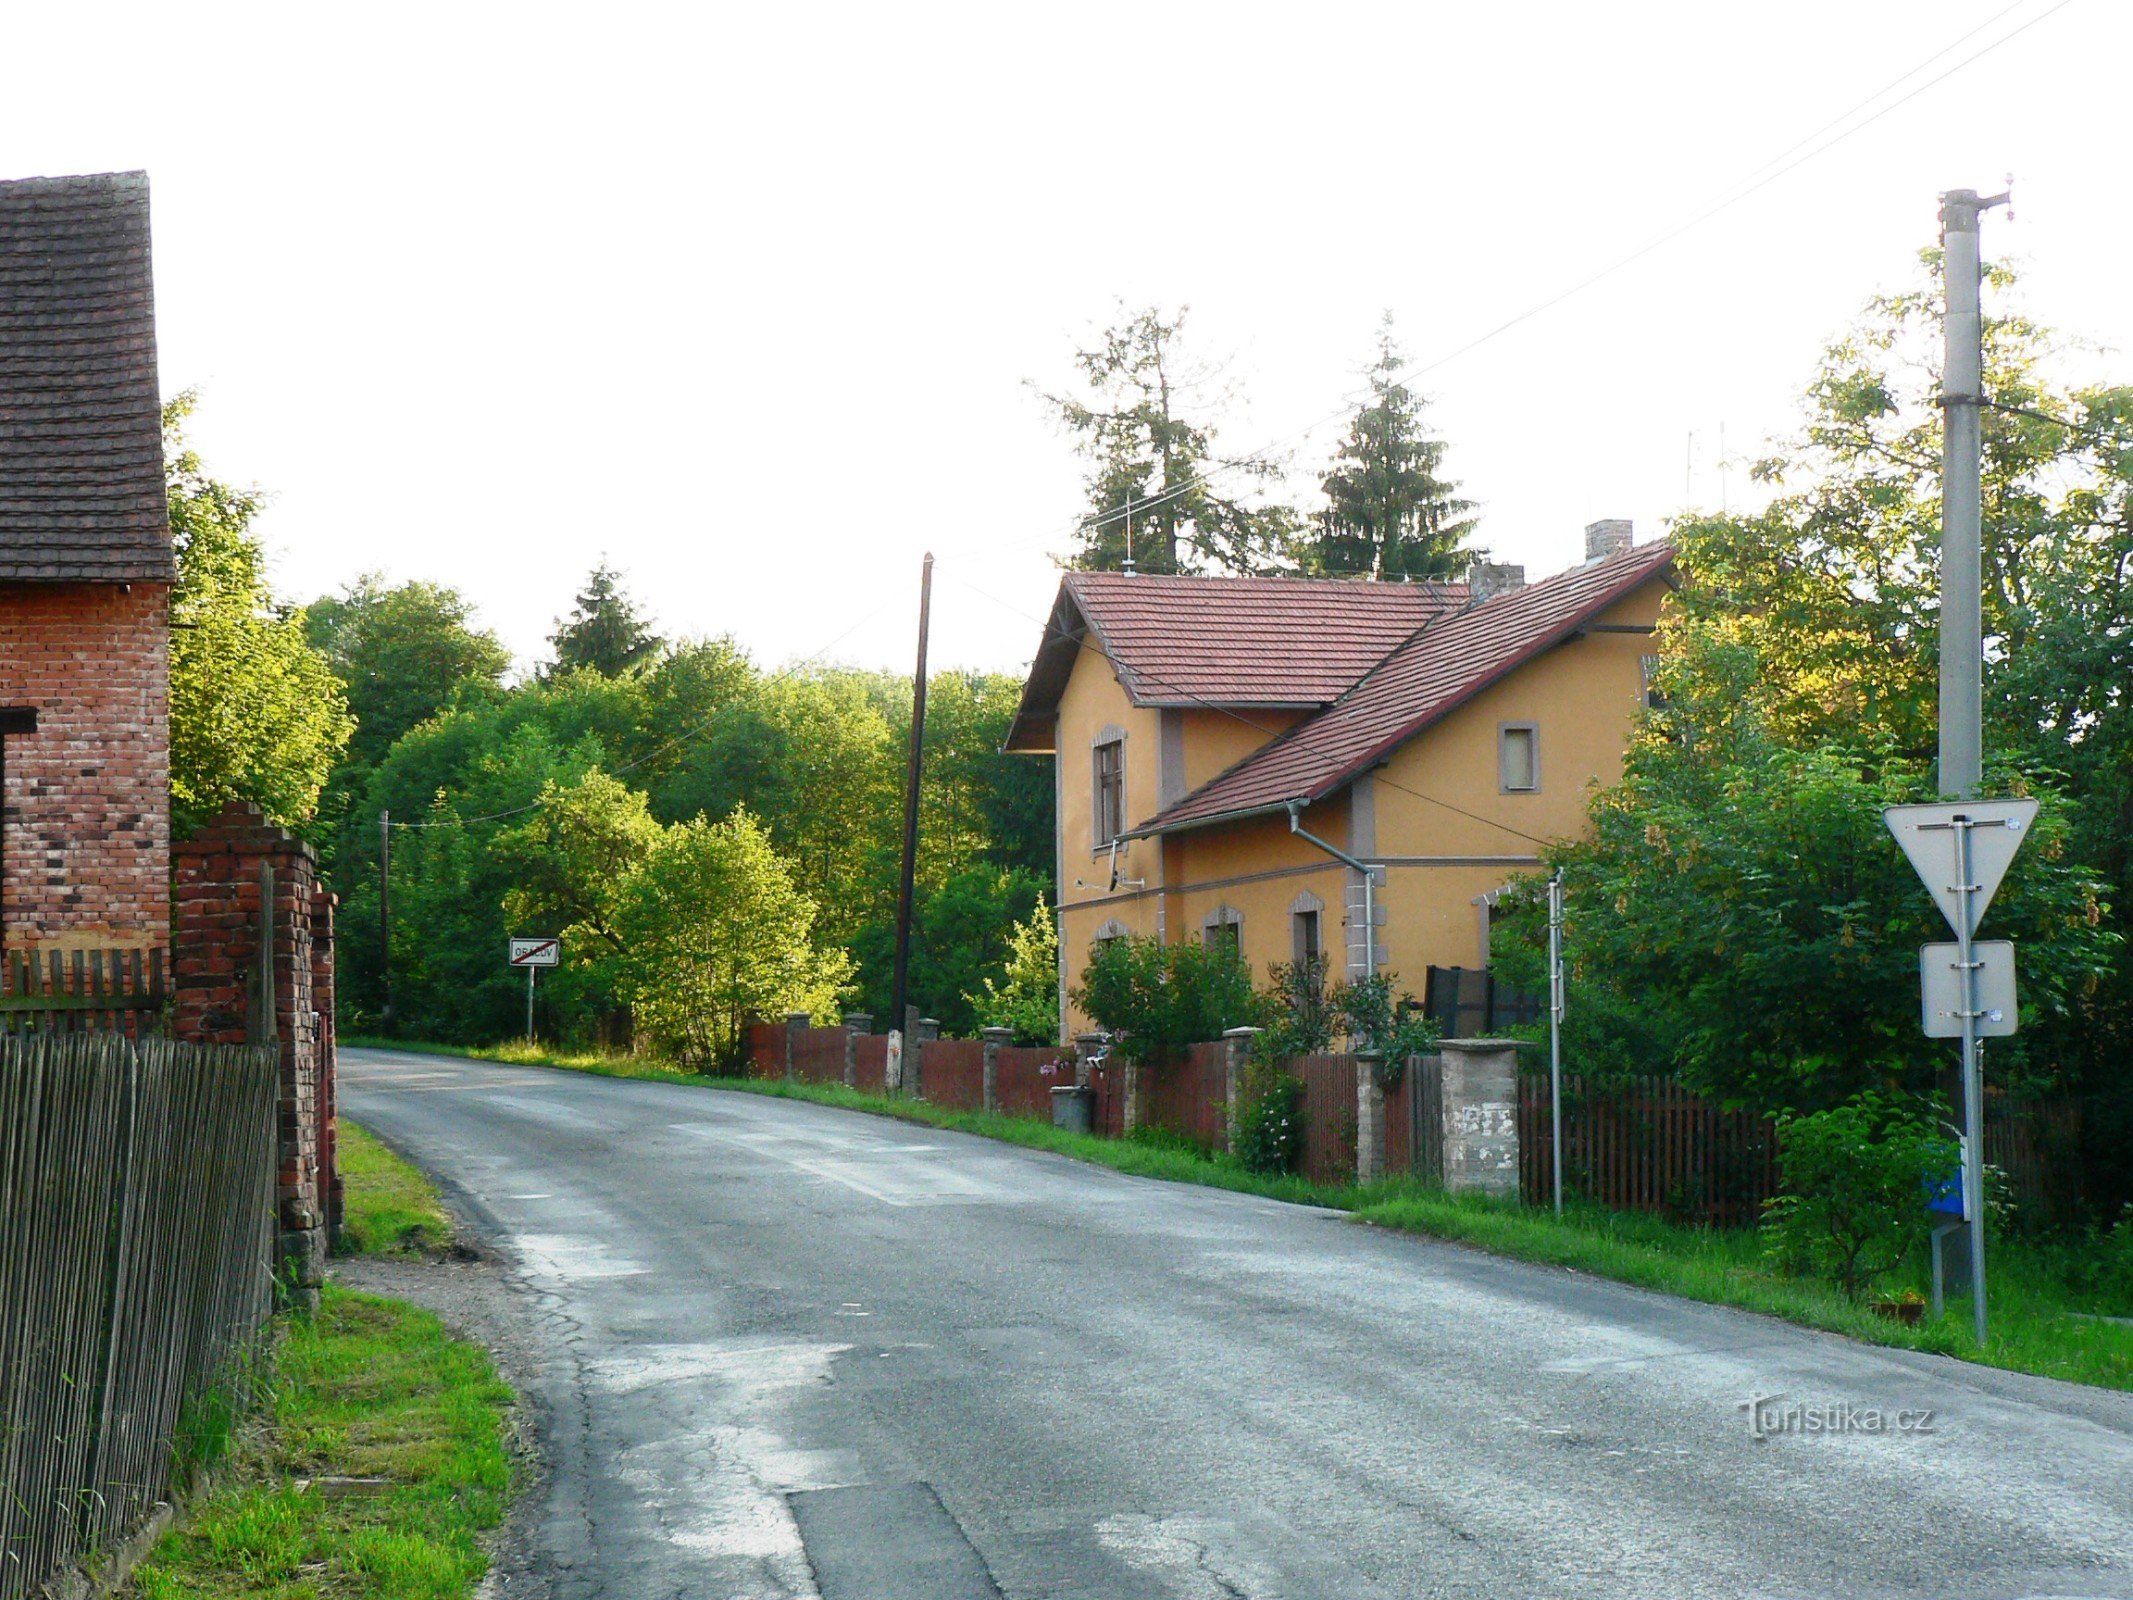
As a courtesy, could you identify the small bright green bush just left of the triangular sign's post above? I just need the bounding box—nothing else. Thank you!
[1764,1090,1958,1299]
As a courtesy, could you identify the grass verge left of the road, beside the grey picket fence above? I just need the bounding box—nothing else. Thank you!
[124,1122,512,1600]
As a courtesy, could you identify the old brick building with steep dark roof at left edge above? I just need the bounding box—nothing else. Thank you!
[0,173,177,949]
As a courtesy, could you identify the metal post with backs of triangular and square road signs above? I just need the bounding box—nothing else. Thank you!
[1881,800,2037,1344]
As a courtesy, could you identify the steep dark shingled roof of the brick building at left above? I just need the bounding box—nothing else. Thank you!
[0,173,177,582]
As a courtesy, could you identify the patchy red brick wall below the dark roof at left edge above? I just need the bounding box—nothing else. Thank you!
[0,582,171,949]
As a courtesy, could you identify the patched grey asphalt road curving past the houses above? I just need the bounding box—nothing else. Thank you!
[343,1050,2133,1600]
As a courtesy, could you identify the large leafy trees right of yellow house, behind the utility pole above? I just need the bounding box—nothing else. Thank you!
[1495,256,2133,1216]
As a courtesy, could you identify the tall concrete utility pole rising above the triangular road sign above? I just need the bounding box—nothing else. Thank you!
[1941,190,2009,800]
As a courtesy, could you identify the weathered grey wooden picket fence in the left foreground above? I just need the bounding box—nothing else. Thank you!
[0,1032,279,1600]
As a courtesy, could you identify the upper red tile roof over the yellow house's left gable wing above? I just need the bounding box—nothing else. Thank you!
[1007,572,1468,751]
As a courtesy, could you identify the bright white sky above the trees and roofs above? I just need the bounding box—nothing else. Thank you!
[0,0,2133,668]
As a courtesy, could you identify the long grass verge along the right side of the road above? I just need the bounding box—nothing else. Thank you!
[350,1039,2133,1389]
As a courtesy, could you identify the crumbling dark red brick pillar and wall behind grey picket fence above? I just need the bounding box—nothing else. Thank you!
[171,804,333,1310]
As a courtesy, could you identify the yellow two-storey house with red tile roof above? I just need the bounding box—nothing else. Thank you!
[1007,521,1674,1035]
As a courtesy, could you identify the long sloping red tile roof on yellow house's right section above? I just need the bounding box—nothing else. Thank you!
[1133,544,1674,834]
